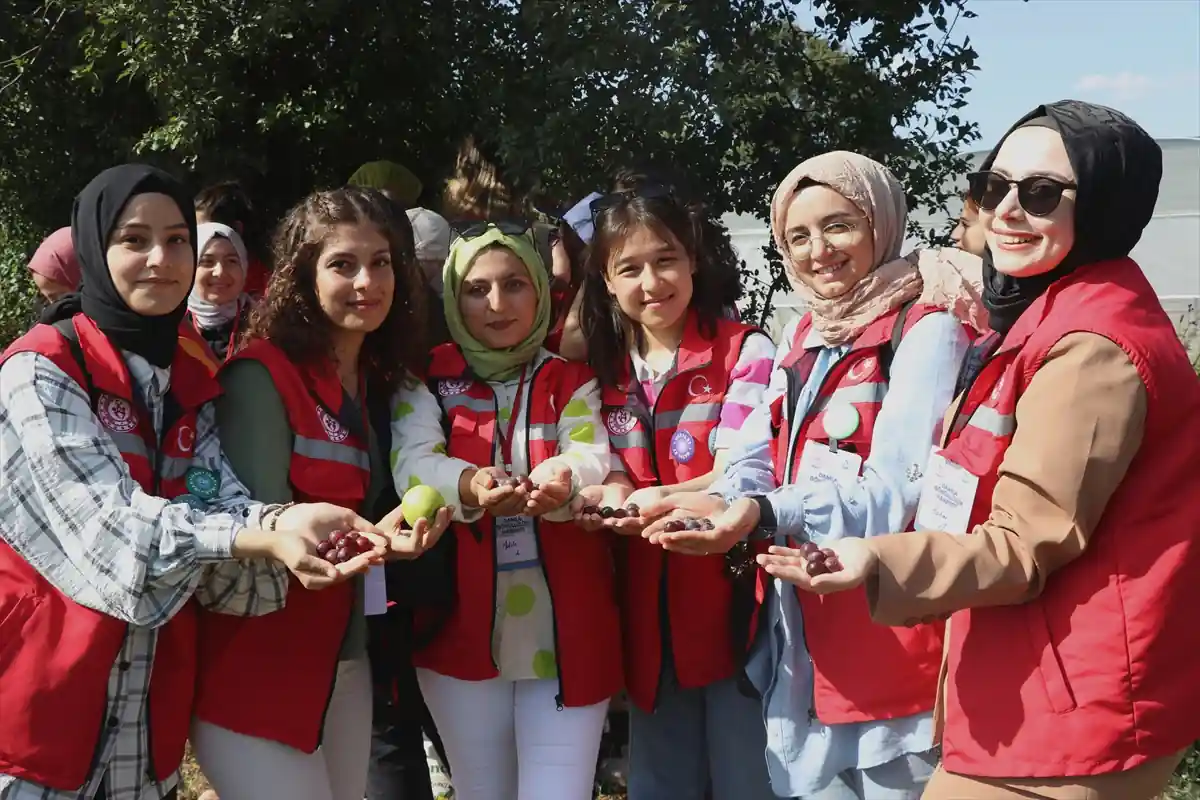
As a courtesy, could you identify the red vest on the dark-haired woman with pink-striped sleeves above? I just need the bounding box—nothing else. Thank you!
[604,313,756,710]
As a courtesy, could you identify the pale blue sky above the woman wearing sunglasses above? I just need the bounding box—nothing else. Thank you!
[954,0,1200,150]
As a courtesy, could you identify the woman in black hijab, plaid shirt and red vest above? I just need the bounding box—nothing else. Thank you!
[0,164,388,800]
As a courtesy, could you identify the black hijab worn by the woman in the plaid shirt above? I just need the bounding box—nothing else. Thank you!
[42,164,196,367]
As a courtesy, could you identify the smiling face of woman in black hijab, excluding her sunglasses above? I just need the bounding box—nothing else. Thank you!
[979,126,1075,277]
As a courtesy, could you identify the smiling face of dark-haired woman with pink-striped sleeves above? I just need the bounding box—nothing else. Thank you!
[605,225,696,331]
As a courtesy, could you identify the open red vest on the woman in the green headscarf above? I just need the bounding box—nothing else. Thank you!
[413,343,622,706]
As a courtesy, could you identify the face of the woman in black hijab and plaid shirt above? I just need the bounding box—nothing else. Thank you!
[106,193,196,317]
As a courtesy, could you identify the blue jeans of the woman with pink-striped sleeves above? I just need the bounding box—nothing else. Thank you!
[629,666,775,800]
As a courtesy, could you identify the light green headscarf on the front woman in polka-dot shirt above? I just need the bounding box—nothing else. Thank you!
[442,227,550,380]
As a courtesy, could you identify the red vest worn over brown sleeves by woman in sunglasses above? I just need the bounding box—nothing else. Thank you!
[942,258,1200,777]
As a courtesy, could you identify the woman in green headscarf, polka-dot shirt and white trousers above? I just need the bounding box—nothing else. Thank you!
[391,223,622,800]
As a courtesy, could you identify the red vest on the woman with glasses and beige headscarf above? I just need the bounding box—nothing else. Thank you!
[758,306,944,724]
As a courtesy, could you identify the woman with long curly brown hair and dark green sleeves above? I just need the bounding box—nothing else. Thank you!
[192,187,450,800]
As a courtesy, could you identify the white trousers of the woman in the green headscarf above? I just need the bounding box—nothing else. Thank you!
[420,669,608,800]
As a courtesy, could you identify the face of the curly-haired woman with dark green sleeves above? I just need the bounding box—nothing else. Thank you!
[316,223,396,335]
